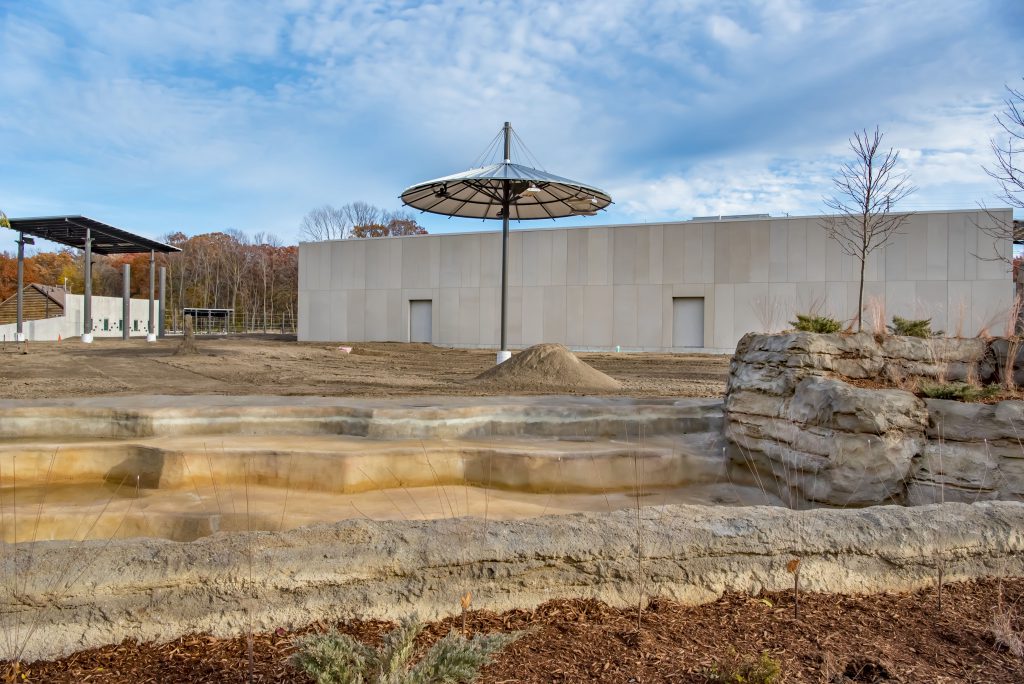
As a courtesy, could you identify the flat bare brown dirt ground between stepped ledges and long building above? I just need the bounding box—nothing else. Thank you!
[0,336,729,399]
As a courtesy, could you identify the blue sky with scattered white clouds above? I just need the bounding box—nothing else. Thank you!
[0,0,1024,250]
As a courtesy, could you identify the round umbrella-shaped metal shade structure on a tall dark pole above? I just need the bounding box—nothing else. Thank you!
[401,121,611,364]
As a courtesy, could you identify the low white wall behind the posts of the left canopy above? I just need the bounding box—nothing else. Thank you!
[0,294,161,342]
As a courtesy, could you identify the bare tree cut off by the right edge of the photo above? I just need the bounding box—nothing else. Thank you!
[975,78,1024,264]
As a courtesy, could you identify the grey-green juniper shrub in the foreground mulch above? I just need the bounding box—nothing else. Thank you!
[292,618,520,684]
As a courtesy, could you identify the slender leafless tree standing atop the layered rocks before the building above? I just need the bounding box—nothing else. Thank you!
[821,126,918,332]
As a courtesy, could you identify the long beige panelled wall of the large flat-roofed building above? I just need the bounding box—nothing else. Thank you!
[299,210,1013,352]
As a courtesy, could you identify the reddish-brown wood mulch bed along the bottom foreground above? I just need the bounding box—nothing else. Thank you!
[9,580,1024,684]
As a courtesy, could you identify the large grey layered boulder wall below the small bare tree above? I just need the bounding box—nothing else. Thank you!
[725,333,1024,506]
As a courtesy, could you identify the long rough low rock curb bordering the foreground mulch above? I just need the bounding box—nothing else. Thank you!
[0,502,1024,661]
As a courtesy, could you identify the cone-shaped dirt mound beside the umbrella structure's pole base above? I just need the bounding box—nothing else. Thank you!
[474,344,622,392]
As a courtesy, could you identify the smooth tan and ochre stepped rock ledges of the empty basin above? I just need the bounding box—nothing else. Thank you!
[0,395,753,542]
